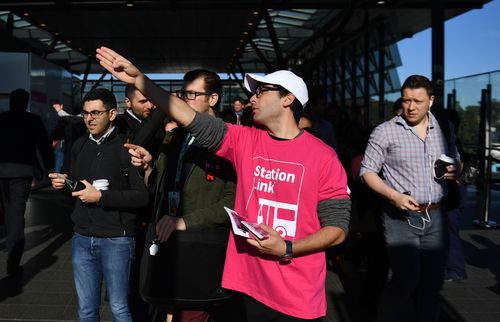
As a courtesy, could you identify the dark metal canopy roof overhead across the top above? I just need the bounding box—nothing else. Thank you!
[0,0,489,74]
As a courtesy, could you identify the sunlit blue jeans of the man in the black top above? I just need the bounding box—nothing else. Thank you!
[72,234,135,322]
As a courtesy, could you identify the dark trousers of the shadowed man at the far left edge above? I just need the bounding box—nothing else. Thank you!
[0,177,33,267]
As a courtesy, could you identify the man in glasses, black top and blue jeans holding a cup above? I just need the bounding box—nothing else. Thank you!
[49,88,149,322]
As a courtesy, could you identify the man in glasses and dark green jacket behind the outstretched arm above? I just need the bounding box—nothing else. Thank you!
[126,69,236,322]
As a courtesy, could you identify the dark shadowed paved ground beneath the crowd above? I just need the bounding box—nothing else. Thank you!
[0,188,500,322]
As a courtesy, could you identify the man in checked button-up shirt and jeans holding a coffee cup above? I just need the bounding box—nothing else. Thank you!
[360,75,459,322]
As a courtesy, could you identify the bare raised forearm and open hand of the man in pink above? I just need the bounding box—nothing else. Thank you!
[96,47,195,126]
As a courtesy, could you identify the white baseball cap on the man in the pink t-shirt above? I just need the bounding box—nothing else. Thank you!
[245,70,309,107]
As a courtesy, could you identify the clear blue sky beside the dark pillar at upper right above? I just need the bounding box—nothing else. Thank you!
[398,0,500,82]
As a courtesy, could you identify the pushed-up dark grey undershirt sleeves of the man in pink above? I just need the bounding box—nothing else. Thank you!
[186,113,351,235]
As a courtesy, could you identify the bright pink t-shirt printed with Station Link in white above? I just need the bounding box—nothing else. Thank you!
[217,124,349,319]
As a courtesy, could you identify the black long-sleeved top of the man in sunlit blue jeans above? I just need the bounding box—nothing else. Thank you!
[70,128,149,237]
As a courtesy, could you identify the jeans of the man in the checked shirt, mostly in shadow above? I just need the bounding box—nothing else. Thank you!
[377,209,448,322]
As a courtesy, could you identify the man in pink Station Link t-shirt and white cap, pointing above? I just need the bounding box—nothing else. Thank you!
[97,47,350,321]
